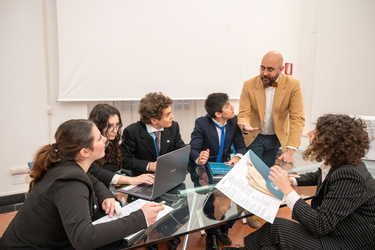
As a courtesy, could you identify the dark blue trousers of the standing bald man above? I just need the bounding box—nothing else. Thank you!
[247,134,281,167]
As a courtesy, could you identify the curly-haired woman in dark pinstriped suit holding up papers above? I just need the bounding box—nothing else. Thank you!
[224,114,375,250]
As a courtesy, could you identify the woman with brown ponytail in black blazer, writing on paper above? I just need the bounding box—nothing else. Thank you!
[0,120,163,249]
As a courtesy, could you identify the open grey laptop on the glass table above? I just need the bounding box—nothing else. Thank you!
[118,145,191,200]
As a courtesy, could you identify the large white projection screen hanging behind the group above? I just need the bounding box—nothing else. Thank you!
[57,0,259,101]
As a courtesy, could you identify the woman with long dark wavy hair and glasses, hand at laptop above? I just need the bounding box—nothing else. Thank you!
[89,104,154,186]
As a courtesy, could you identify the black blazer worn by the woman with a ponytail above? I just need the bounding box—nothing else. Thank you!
[0,161,147,249]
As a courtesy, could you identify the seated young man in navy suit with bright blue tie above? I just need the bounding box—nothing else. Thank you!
[190,93,250,250]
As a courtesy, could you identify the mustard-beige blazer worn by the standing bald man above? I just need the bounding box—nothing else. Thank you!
[238,74,305,151]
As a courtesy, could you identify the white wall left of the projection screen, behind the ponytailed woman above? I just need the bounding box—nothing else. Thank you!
[0,0,87,196]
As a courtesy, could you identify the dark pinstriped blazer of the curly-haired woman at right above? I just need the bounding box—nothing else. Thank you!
[292,163,375,249]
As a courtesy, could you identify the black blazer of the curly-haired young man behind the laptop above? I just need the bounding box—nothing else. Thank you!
[121,121,185,176]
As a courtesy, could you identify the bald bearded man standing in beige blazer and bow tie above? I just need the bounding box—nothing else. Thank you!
[238,51,305,167]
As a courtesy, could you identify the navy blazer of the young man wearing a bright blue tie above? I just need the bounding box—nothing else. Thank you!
[190,115,246,165]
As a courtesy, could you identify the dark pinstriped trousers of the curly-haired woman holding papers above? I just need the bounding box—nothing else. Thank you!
[244,218,323,250]
